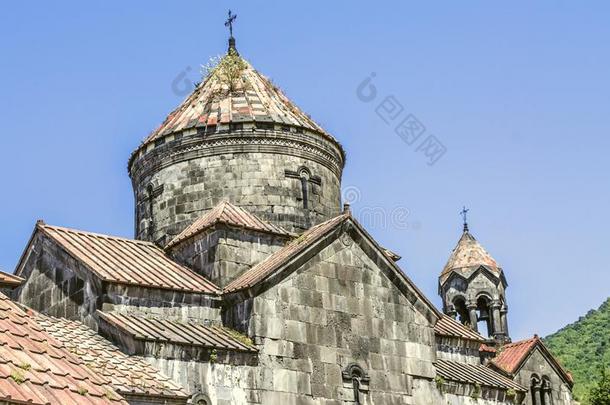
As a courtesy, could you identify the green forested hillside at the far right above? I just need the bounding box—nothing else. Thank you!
[544,298,610,404]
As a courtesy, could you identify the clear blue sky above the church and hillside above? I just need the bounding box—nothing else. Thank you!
[0,1,610,338]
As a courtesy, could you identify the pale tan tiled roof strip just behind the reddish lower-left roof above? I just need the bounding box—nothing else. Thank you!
[36,315,190,401]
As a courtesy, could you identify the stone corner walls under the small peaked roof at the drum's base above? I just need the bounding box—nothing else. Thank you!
[171,225,288,288]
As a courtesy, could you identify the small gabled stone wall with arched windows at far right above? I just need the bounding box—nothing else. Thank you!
[515,348,572,405]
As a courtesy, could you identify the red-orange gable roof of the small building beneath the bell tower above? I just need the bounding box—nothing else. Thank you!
[491,335,574,385]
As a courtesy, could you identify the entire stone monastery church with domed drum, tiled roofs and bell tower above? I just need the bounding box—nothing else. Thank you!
[0,27,574,405]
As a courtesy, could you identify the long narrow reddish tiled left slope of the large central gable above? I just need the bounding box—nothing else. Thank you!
[224,214,349,293]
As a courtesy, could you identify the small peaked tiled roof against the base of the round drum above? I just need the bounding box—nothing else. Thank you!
[166,201,289,249]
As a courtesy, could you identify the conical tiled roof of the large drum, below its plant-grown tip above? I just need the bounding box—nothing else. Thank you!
[139,56,338,148]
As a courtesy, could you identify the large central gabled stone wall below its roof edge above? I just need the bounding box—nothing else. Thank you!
[230,238,435,405]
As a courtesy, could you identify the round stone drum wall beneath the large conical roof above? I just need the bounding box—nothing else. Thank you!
[130,129,343,242]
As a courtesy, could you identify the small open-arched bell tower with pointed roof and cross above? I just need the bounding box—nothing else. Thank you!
[438,213,510,343]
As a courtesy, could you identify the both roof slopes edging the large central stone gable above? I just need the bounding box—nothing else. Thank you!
[223,210,441,318]
